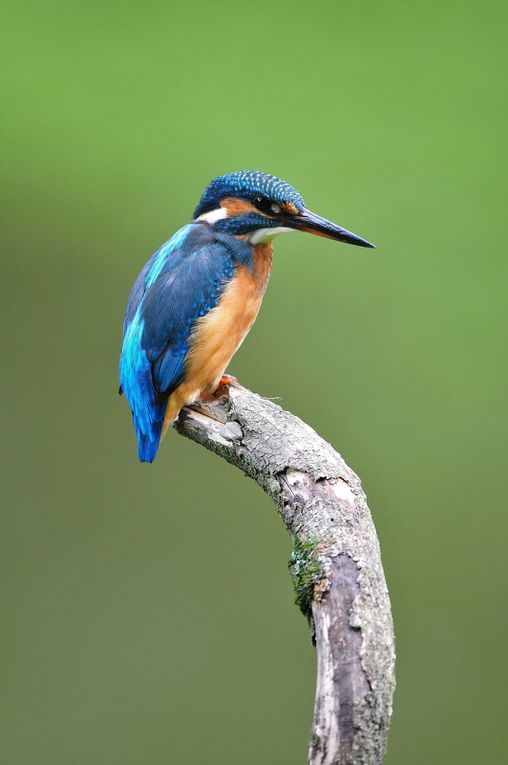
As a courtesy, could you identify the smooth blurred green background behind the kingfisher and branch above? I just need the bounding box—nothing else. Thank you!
[0,0,508,765]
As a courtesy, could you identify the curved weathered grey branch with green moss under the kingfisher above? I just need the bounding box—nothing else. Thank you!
[175,385,395,765]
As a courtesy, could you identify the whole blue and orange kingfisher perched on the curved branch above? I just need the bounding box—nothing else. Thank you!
[119,170,374,463]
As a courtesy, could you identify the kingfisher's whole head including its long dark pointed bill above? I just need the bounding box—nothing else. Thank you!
[194,170,374,247]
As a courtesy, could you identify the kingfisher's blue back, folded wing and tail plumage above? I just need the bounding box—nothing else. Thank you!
[120,224,252,462]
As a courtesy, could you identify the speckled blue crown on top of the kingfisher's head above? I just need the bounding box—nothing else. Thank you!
[194,170,305,218]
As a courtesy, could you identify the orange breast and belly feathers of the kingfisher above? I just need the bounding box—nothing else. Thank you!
[164,244,272,433]
